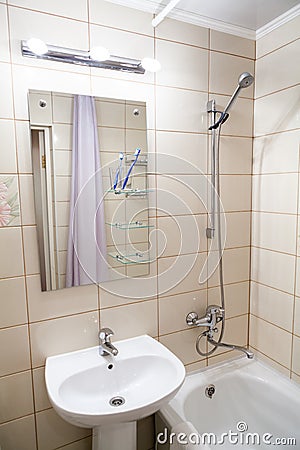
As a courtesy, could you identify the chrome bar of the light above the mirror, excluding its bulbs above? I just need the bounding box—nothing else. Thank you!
[21,41,145,75]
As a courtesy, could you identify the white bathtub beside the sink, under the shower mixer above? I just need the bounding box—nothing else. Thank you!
[156,357,300,450]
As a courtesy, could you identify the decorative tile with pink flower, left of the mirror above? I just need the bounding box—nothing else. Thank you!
[0,175,20,227]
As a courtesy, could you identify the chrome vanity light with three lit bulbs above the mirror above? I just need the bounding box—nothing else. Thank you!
[21,38,160,75]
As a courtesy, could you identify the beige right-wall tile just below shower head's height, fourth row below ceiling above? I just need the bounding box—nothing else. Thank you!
[253,131,299,174]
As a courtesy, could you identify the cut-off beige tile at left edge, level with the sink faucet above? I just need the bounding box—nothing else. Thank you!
[0,325,30,376]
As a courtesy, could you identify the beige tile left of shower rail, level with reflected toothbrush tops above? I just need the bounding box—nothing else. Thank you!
[156,131,207,174]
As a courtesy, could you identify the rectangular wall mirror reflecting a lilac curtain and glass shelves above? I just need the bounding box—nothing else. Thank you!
[29,91,151,291]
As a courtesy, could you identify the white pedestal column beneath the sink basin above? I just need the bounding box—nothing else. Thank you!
[93,422,136,450]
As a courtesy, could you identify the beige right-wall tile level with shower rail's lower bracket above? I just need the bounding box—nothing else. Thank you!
[252,212,297,254]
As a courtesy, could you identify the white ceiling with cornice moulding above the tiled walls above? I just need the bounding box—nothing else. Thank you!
[107,0,300,39]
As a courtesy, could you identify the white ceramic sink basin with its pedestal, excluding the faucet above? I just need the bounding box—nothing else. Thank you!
[45,335,185,450]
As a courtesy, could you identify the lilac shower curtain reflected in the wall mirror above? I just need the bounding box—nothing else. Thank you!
[66,95,108,287]
